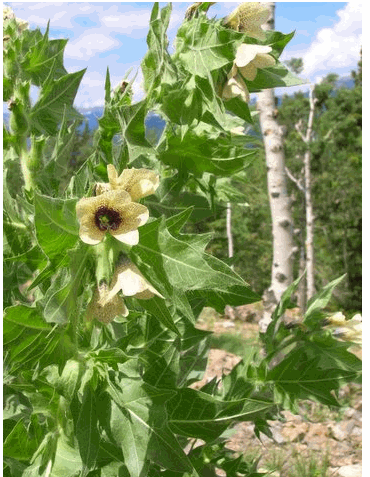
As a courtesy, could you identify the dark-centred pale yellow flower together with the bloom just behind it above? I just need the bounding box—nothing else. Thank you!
[76,164,159,245]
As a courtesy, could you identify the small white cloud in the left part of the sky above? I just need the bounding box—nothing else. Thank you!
[65,29,120,61]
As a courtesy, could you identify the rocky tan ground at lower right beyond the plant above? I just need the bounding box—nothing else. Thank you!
[196,310,362,477]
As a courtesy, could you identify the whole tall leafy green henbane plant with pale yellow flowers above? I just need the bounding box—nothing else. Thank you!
[3,3,360,477]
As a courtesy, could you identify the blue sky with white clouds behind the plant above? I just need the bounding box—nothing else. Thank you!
[5,1,362,108]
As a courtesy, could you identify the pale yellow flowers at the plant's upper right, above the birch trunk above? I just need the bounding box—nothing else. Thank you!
[222,2,276,102]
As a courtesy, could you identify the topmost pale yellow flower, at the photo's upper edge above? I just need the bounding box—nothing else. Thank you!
[224,2,270,40]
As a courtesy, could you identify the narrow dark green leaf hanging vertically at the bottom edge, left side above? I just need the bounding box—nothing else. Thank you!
[76,385,100,477]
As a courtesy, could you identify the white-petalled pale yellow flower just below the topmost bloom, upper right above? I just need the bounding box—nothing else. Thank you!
[231,43,276,81]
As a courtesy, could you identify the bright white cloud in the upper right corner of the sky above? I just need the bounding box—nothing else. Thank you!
[290,2,362,78]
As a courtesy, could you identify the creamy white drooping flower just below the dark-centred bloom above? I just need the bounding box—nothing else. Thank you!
[110,258,163,300]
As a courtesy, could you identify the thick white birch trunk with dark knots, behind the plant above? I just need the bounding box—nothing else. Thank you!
[257,3,296,316]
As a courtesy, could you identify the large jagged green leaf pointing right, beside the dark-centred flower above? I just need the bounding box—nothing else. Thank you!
[130,219,259,308]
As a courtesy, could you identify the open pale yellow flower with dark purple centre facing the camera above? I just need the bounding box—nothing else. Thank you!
[76,190,149,245]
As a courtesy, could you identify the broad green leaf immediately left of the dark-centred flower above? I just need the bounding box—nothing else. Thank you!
[35,193,78,261]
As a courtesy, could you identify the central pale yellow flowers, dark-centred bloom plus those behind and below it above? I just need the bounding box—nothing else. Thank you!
[76,164,163,323]
